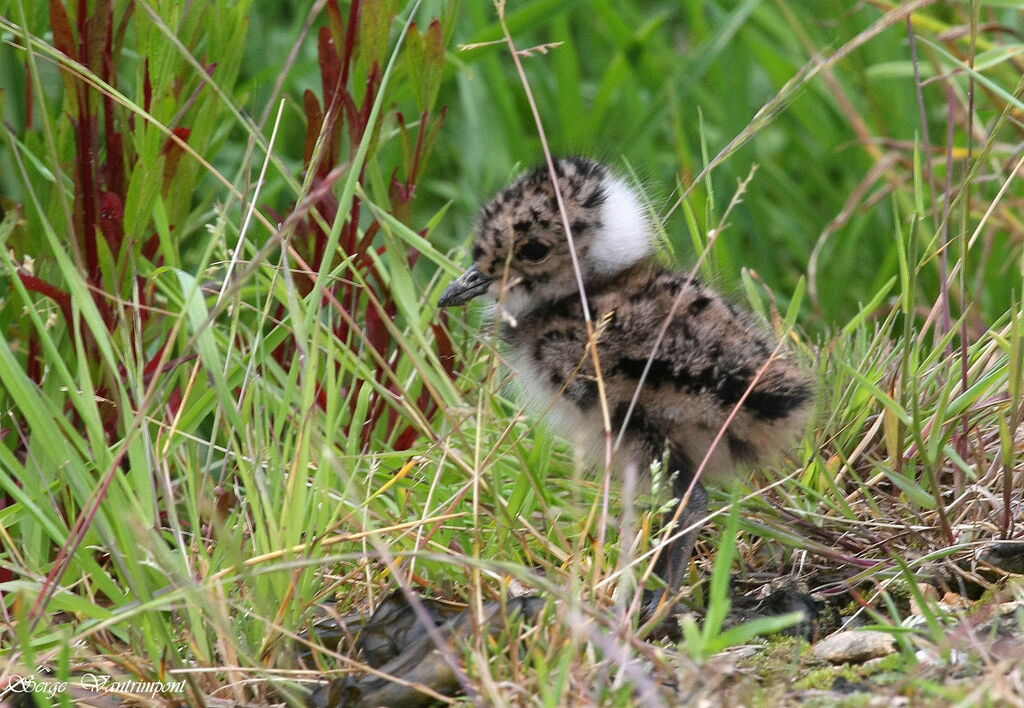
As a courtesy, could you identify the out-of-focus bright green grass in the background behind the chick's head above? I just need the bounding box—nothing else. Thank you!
[6,0,1024,331]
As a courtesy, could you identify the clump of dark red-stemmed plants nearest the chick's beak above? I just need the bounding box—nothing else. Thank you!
[274,0,455,450]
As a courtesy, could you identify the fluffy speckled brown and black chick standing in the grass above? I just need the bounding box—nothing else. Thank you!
[438,158,811,610]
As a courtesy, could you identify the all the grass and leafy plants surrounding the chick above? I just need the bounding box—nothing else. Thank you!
[0,0,1024,706]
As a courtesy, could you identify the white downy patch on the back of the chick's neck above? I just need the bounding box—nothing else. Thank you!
[589,176,654,274]
